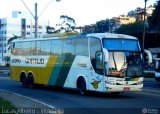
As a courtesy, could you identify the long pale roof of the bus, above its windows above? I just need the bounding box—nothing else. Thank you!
[13,33,137,42]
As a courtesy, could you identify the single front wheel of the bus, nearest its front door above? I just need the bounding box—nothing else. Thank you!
[77,77,86,95]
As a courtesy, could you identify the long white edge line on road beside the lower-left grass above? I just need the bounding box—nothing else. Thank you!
[0,89,55,108]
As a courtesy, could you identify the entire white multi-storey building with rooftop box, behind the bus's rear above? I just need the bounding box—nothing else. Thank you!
[0,11,46,65]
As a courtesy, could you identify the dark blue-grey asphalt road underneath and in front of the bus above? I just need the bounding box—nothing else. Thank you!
[0,74,160,114]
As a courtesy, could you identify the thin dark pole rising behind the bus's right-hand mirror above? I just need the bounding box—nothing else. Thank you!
[142,0,147,51]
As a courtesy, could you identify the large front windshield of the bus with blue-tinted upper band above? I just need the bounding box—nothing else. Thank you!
[103,39,142,77]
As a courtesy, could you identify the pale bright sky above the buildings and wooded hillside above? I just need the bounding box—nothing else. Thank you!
[0,0,157,26]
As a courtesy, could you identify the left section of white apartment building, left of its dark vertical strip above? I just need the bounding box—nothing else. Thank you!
[0,18,21,64]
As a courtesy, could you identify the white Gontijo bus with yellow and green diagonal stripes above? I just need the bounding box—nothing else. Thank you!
[10,33,151,94]
